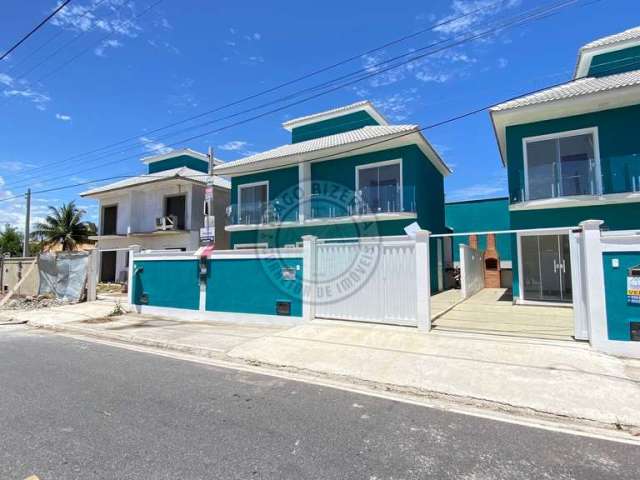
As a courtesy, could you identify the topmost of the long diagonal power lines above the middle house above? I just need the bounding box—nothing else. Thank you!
[2,0,507,181]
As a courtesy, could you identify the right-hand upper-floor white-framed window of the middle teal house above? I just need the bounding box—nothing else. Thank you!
[356,160,402,213]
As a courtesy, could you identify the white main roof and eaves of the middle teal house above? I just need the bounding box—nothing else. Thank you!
[214,125,451,177]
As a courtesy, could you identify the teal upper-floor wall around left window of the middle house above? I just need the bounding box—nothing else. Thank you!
[231,166,298,220]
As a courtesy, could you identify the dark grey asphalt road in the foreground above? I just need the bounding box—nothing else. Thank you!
[0,327,640,480]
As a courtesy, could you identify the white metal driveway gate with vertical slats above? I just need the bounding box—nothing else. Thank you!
[316,239,418,326]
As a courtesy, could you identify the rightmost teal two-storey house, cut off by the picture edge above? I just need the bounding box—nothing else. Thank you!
[490,28,640,303]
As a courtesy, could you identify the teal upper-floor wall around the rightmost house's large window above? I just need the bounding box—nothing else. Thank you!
[506,105,640,199]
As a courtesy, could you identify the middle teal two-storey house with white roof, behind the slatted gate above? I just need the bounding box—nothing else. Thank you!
[214,101,451,290]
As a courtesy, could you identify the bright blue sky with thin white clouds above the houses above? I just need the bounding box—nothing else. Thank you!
[0,0,640,225]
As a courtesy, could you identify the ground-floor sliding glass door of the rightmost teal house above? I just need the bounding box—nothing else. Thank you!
[520,235,572,302]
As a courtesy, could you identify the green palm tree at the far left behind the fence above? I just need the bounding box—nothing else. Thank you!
[33,201,96,251]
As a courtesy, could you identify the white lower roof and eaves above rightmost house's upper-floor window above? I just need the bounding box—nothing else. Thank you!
[489,79,640,165]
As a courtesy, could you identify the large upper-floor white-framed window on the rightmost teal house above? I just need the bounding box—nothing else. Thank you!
[523,128,600,200]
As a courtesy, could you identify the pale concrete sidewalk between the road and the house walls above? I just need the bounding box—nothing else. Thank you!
[8,300,640,428]
